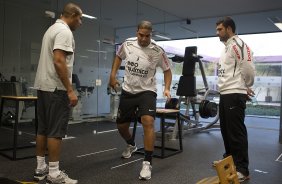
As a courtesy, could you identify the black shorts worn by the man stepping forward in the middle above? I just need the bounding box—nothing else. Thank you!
[116,91,157,123]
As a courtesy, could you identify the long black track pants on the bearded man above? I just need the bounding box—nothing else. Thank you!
[219,93,249,176]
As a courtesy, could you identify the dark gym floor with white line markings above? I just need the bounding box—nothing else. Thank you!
[0,117,282,184]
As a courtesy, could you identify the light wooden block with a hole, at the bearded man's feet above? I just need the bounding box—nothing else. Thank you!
[197,156,239,184]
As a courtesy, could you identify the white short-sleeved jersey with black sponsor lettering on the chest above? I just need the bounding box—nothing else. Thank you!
[117,37,170,94]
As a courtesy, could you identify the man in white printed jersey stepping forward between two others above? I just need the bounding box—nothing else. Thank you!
[109,21,172,180]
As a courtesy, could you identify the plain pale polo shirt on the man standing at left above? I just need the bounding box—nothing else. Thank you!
[34,19,75,92]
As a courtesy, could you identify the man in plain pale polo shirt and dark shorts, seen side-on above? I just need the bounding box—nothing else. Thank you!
[34,3,82,184]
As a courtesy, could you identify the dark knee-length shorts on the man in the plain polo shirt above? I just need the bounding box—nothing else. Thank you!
[37,90,70,138]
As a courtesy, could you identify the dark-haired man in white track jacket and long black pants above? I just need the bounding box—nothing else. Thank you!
[216,17,255,182]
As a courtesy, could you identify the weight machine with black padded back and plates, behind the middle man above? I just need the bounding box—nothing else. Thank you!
[166,47,219,139]
